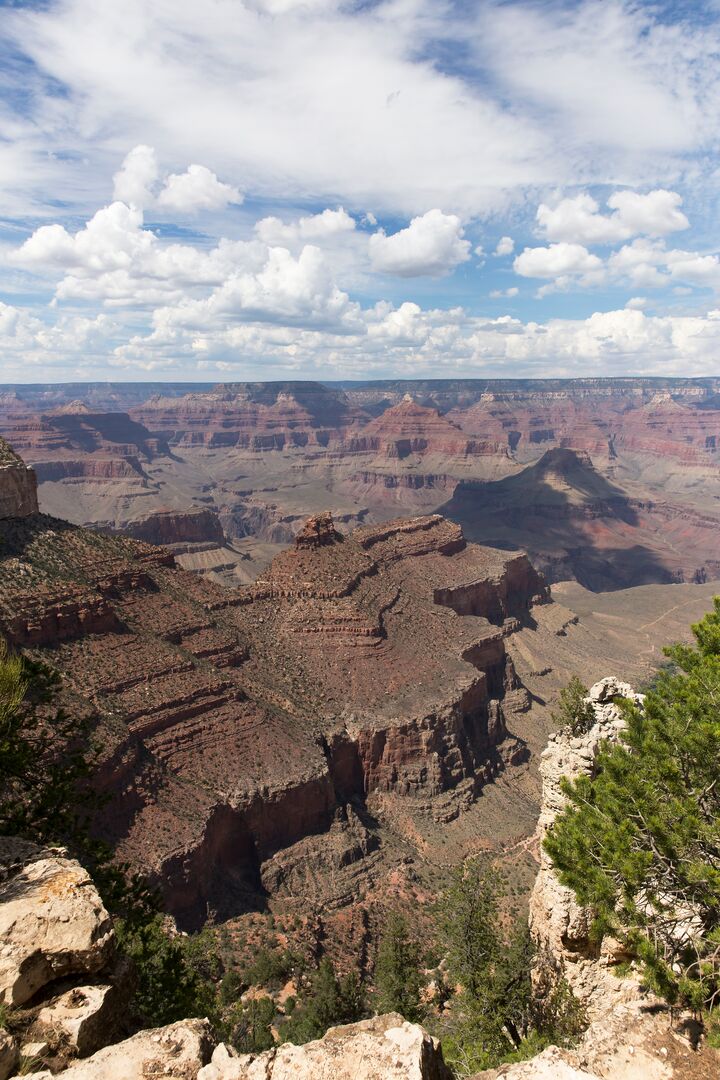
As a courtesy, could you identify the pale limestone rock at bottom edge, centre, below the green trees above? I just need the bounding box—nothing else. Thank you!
[198,1013,450,1080]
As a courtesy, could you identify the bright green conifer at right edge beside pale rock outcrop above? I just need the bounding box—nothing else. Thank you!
[545,597,720,1012]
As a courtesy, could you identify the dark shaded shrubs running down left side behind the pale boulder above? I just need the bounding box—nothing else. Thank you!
[0,639,219,1026]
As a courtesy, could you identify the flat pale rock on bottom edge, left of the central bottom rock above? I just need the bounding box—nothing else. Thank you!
[21,1020,213,1080]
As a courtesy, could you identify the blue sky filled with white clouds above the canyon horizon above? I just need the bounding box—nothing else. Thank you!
[0,0,720,382]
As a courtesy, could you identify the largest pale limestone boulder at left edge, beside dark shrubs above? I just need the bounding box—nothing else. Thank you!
[0,838,114,1004]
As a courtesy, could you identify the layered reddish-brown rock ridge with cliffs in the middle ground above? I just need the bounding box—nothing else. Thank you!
[0,457,548,927]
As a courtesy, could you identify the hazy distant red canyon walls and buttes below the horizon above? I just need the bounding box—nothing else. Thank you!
[0,379,720,591]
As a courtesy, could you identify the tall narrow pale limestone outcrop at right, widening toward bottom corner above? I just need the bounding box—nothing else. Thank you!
[475,677,720,1080]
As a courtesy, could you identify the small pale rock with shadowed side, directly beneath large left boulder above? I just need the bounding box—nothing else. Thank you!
[38,986,120,1057]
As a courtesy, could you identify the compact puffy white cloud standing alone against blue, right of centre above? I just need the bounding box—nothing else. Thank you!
[369,210,471,278]
